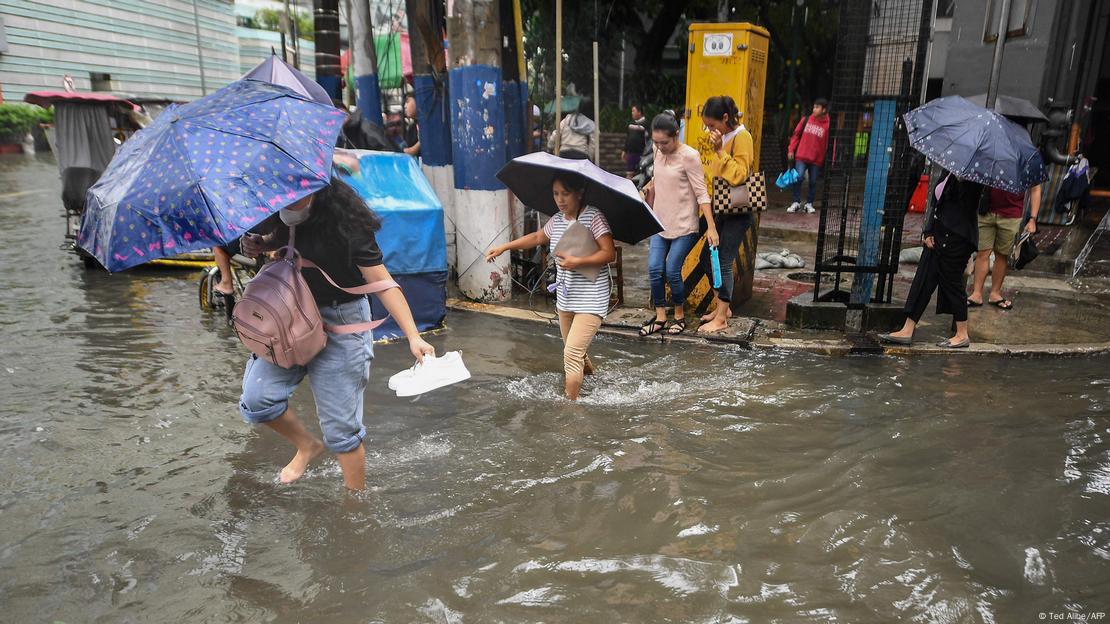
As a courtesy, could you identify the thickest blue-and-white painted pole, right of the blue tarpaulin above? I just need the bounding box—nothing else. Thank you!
[447,0,516,301]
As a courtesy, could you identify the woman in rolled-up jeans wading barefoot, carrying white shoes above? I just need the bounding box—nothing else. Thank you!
[239,178,435,490]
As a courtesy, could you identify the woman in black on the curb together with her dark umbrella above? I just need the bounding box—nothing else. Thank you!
[878,95,1048,349]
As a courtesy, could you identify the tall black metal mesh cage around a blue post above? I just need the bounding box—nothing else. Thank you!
[814,0,934,308]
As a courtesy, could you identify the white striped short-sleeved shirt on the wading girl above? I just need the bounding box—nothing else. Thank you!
[544,205,612,318]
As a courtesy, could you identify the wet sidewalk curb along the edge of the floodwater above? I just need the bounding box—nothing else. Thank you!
[447,298,1110,358]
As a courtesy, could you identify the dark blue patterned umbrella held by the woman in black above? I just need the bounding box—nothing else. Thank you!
[905,95,1048,193]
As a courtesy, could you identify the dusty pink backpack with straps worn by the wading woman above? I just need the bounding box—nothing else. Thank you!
[232,227,400,369]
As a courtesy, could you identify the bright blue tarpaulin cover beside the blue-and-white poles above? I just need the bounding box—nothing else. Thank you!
[342,150,447,340]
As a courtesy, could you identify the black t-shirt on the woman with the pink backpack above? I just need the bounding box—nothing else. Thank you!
[279,219,382,305]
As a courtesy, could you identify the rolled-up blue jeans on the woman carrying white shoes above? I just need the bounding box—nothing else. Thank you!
[239,296,374,453]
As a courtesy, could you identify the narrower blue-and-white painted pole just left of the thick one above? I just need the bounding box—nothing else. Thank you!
[405,0,460,273]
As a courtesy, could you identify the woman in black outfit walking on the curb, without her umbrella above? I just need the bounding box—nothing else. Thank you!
[879,174,989,349]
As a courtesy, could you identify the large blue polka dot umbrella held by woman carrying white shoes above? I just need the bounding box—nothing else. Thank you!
[78,80,343,271]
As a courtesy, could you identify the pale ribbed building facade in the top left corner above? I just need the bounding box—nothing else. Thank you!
[0,0,242,101]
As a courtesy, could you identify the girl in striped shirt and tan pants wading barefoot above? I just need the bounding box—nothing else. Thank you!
[486,173,616,401]
